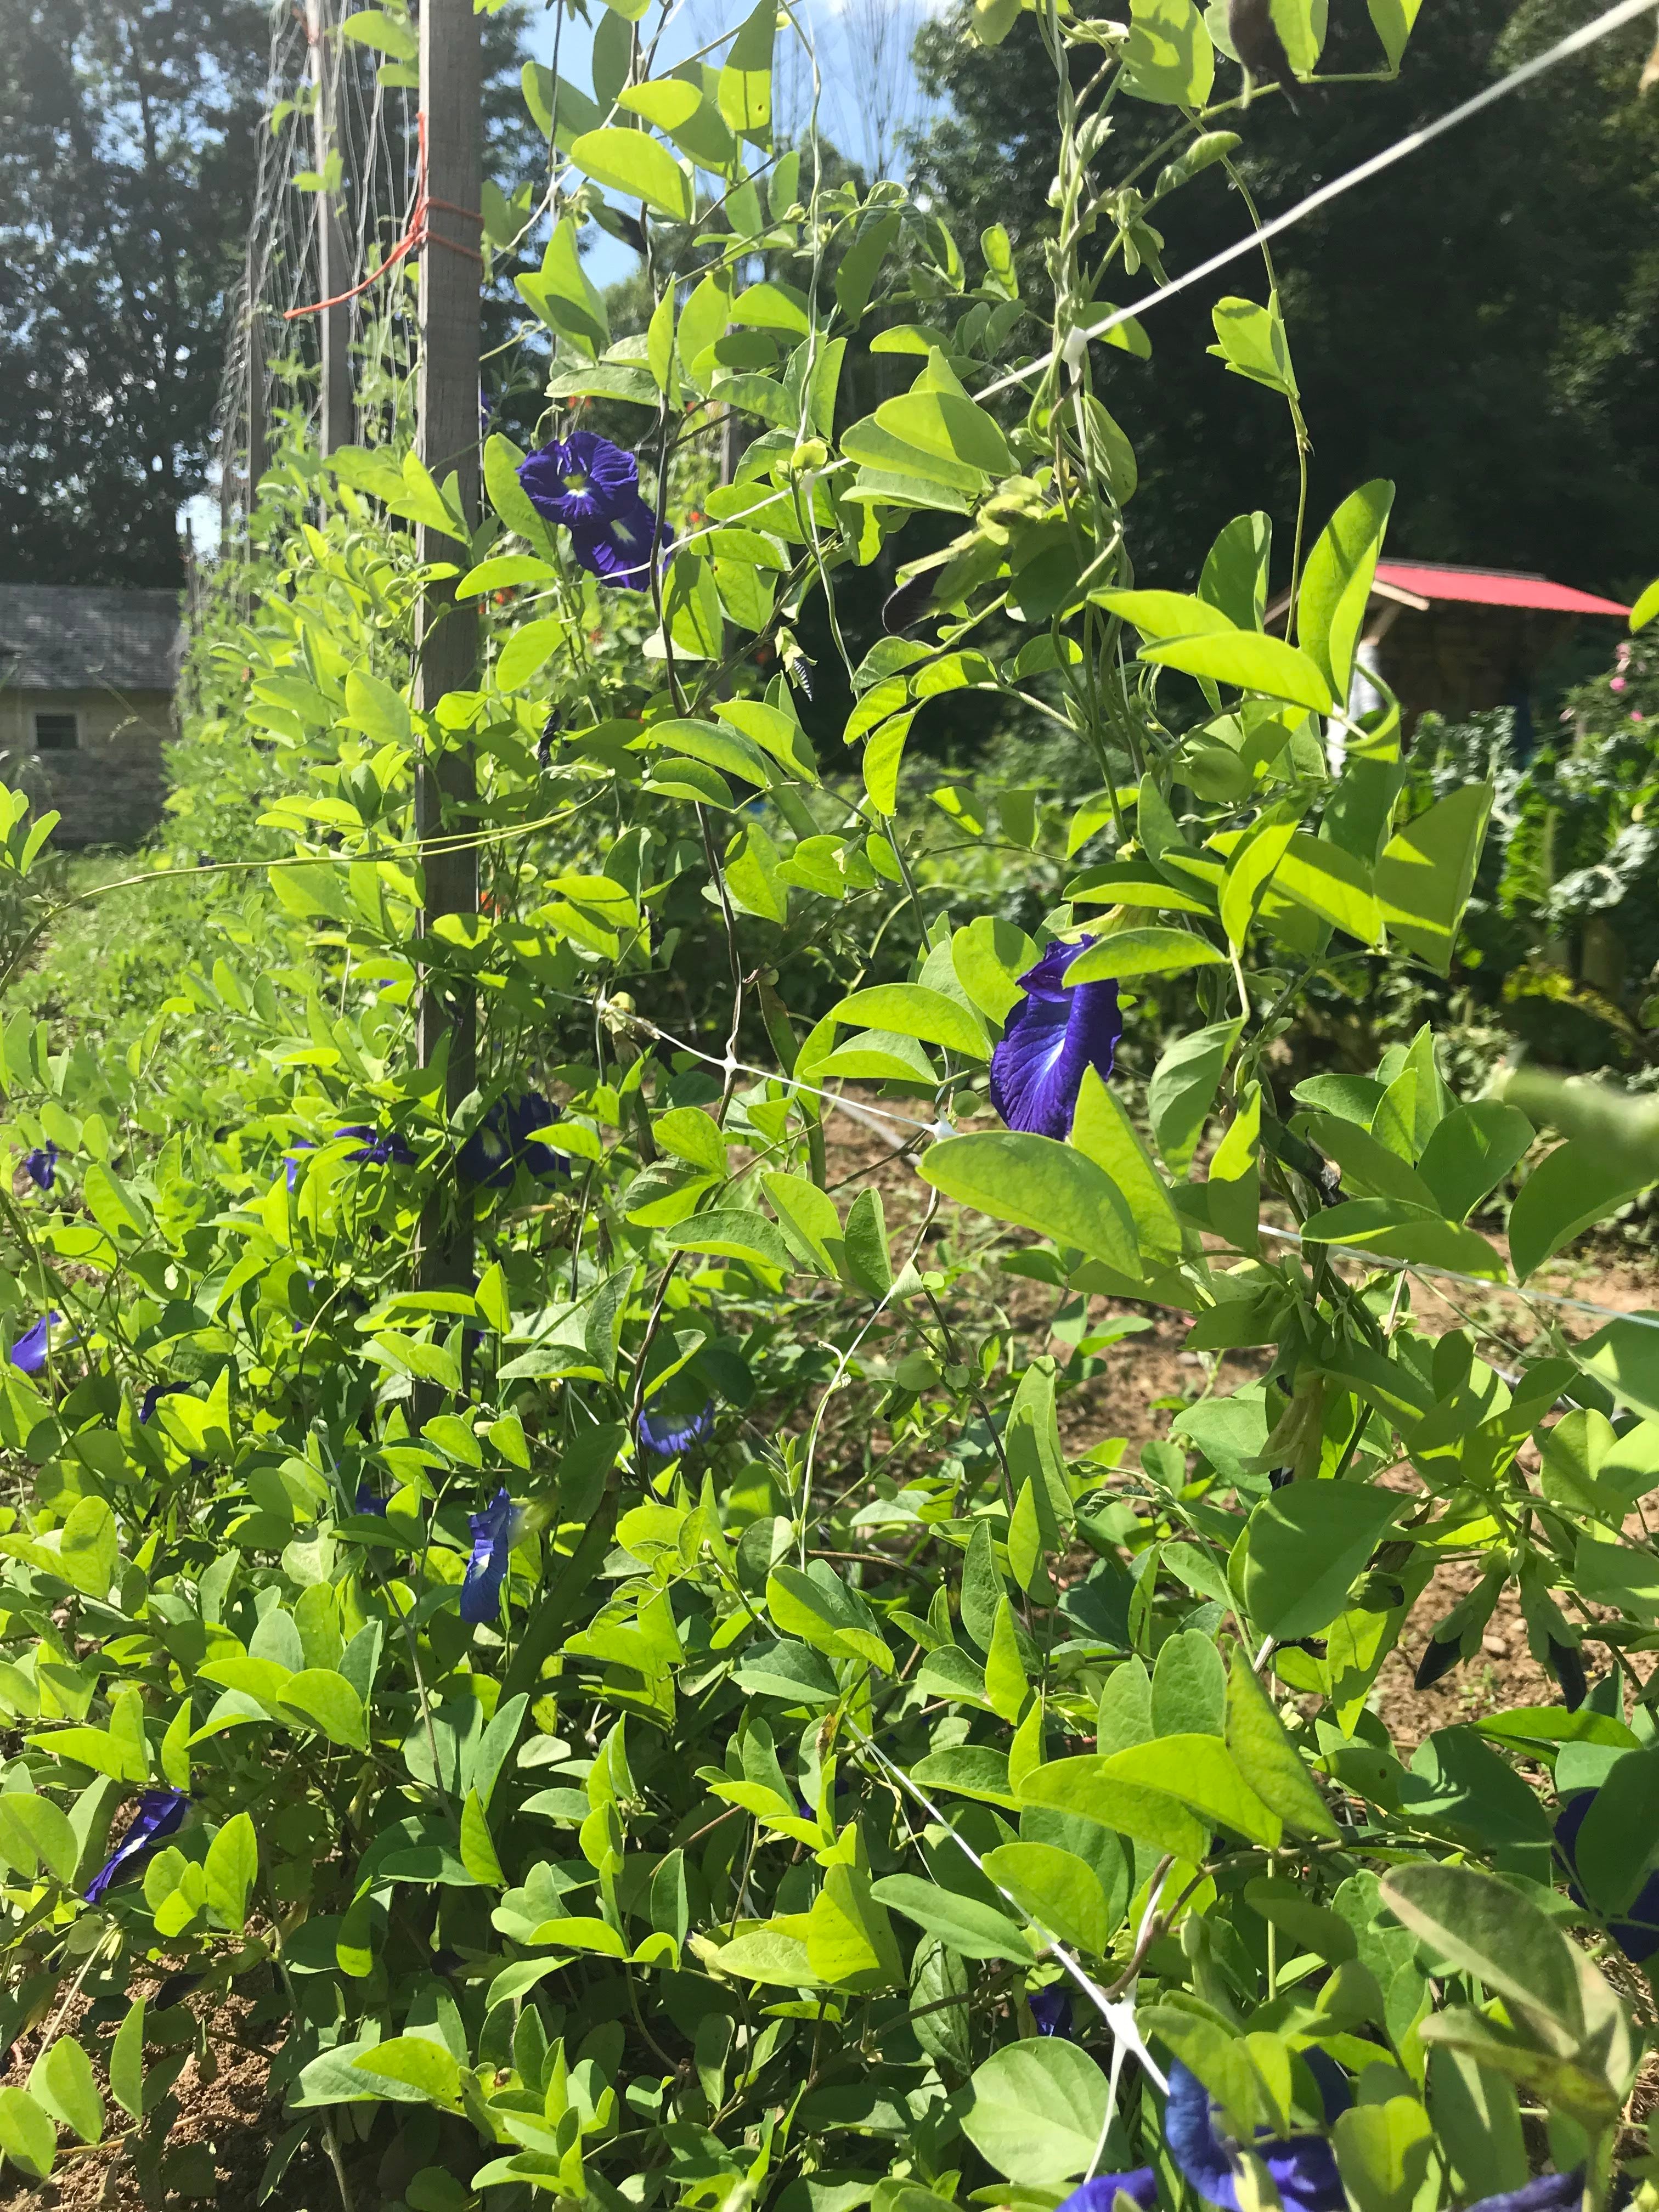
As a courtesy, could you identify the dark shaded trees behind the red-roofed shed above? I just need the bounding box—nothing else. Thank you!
[918,0,1659,593]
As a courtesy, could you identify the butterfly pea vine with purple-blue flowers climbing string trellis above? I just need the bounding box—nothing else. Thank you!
[0,0,1659,2212]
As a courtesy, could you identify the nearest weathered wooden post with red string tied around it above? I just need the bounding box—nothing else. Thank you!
[416,0,482,1288]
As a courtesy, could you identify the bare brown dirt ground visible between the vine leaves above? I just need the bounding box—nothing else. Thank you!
[0,1099,1659,2212]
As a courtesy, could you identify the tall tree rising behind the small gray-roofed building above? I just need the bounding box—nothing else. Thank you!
[0,0,268,584]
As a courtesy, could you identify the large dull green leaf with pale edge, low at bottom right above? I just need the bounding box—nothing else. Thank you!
[1383,1865,1584,2051]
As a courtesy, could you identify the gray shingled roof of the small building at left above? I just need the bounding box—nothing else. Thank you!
[0,584,184,692]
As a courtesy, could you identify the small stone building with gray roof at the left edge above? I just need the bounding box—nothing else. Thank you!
[0,584,184,845]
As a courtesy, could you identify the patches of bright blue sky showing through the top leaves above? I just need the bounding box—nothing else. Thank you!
[529,0,936,285]
